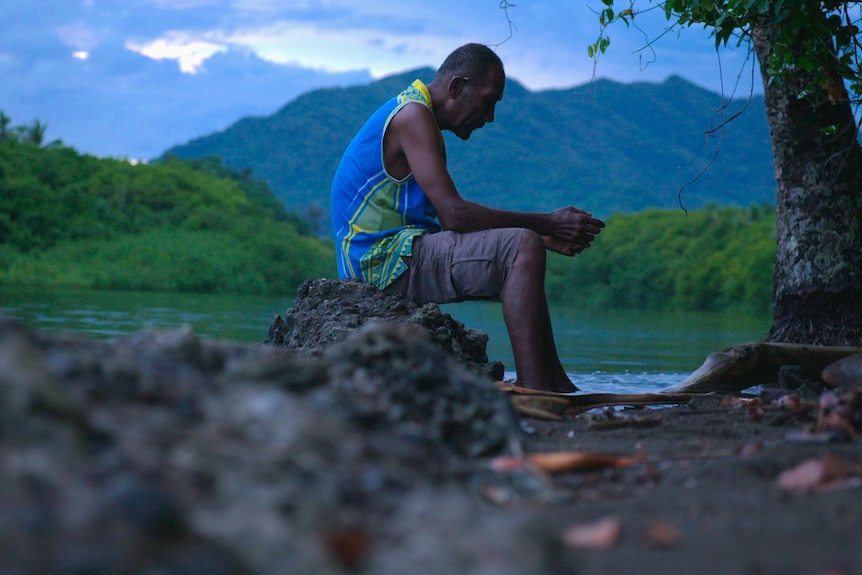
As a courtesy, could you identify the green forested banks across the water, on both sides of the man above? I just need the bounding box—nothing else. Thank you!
[0,112,775,313]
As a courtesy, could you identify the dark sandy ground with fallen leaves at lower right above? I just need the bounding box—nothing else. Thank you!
[500,396,862,575]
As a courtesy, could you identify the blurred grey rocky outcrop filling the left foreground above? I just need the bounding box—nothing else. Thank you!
[0,316,548,575]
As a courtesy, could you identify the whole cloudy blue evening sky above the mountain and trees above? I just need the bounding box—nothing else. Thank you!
[0,0,759,160]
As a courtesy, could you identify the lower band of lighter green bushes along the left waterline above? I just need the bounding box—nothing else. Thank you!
[0,225,334,294]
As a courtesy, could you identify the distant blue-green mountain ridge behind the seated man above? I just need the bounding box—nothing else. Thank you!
[166,68,775,220]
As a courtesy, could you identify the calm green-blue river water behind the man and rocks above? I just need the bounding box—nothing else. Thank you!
[0,288,770,392]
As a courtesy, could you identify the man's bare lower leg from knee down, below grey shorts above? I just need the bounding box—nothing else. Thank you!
[501,231,578,392]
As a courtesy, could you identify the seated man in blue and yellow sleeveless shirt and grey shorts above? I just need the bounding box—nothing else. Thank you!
[332,44,604,392]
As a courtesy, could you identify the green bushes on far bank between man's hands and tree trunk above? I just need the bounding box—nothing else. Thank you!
[547,206,776,313]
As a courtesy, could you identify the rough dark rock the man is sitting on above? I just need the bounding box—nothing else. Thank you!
[265,279,504,381]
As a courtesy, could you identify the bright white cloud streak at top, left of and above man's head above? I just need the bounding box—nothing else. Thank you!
[115,0,504,77]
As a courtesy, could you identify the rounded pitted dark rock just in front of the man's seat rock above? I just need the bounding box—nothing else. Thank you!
[324,322,514,457]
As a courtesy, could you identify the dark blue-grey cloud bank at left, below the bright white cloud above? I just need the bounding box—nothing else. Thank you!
[0,3,369,158]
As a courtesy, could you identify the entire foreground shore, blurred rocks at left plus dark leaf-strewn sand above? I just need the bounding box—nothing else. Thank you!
[0,310,862,575]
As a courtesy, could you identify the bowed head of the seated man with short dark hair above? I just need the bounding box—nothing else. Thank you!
[432,44,506,140]
